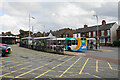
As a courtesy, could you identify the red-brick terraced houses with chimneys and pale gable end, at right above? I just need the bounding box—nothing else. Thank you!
[73,20,118,46]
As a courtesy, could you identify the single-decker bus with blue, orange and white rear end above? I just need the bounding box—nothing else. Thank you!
[49,37,87,51]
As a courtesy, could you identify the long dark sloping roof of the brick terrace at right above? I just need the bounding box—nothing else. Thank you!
[74,22,115,34]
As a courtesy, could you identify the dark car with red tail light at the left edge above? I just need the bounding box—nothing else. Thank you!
[0,44,12,56]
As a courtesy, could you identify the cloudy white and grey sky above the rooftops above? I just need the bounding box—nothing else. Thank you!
[0,0,118,34]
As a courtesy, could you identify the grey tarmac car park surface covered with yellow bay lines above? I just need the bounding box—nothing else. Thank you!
[0,45,120,80]
